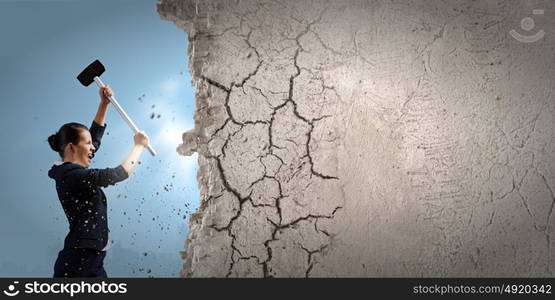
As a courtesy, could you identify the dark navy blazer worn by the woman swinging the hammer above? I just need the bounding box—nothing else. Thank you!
[48,121,128,250]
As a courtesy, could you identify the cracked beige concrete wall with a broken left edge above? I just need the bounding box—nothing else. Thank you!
[158,0,555,277]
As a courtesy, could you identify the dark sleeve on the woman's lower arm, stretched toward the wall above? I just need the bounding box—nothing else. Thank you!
[66,165,129,187]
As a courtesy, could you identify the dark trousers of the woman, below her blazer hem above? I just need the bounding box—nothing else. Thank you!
[54,248,108,278]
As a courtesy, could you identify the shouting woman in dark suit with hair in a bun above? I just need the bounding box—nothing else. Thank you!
[48,86,149,278]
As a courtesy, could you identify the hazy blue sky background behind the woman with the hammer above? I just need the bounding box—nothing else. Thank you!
[0,0,199,277]
